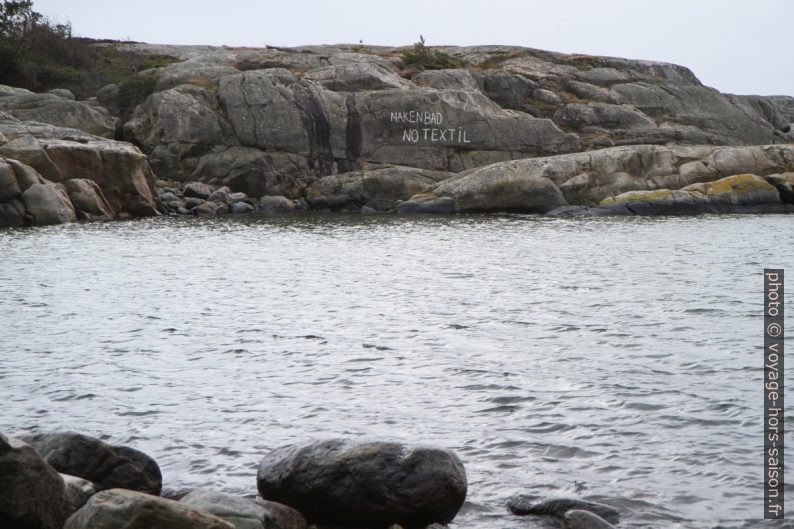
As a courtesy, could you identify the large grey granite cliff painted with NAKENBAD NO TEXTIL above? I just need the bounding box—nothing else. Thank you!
[105,44,794,206]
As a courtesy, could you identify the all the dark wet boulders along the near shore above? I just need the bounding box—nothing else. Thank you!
[0,432,620,529]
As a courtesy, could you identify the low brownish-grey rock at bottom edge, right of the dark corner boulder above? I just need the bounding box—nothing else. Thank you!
[64,489,234,529]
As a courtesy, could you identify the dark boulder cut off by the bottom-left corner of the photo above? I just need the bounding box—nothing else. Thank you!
[0,434,68,529]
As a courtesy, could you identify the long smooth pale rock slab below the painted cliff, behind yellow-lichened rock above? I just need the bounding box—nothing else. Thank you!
[409,145,794,213]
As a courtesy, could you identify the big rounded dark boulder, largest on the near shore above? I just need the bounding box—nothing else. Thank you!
[257,440,467,528]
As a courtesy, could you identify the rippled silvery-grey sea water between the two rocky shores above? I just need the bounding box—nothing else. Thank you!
[0,215,794,529]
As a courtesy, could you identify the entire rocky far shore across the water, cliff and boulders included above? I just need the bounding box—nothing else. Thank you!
[0,44,794,226]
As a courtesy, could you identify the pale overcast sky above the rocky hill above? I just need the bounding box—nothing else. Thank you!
[34,0,794,95]
